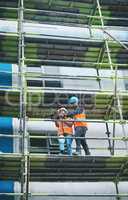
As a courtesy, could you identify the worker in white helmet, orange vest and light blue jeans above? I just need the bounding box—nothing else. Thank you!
[55,108,73,156]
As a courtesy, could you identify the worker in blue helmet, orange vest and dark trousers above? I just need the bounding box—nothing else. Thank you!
[68,96,90,155]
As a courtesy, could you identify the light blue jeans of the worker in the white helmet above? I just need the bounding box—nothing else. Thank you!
[58,134,73,156]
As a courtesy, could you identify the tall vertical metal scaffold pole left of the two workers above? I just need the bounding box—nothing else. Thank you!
[18,0,29,200]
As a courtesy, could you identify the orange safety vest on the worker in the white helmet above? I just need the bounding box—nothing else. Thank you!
[57,121,73,135]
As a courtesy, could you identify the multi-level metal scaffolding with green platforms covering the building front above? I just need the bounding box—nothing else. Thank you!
[0,0,128,200]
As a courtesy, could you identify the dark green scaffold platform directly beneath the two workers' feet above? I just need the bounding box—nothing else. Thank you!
[0,154,128,182]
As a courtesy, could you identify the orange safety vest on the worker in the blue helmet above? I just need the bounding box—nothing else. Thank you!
[74,113,88,127]
